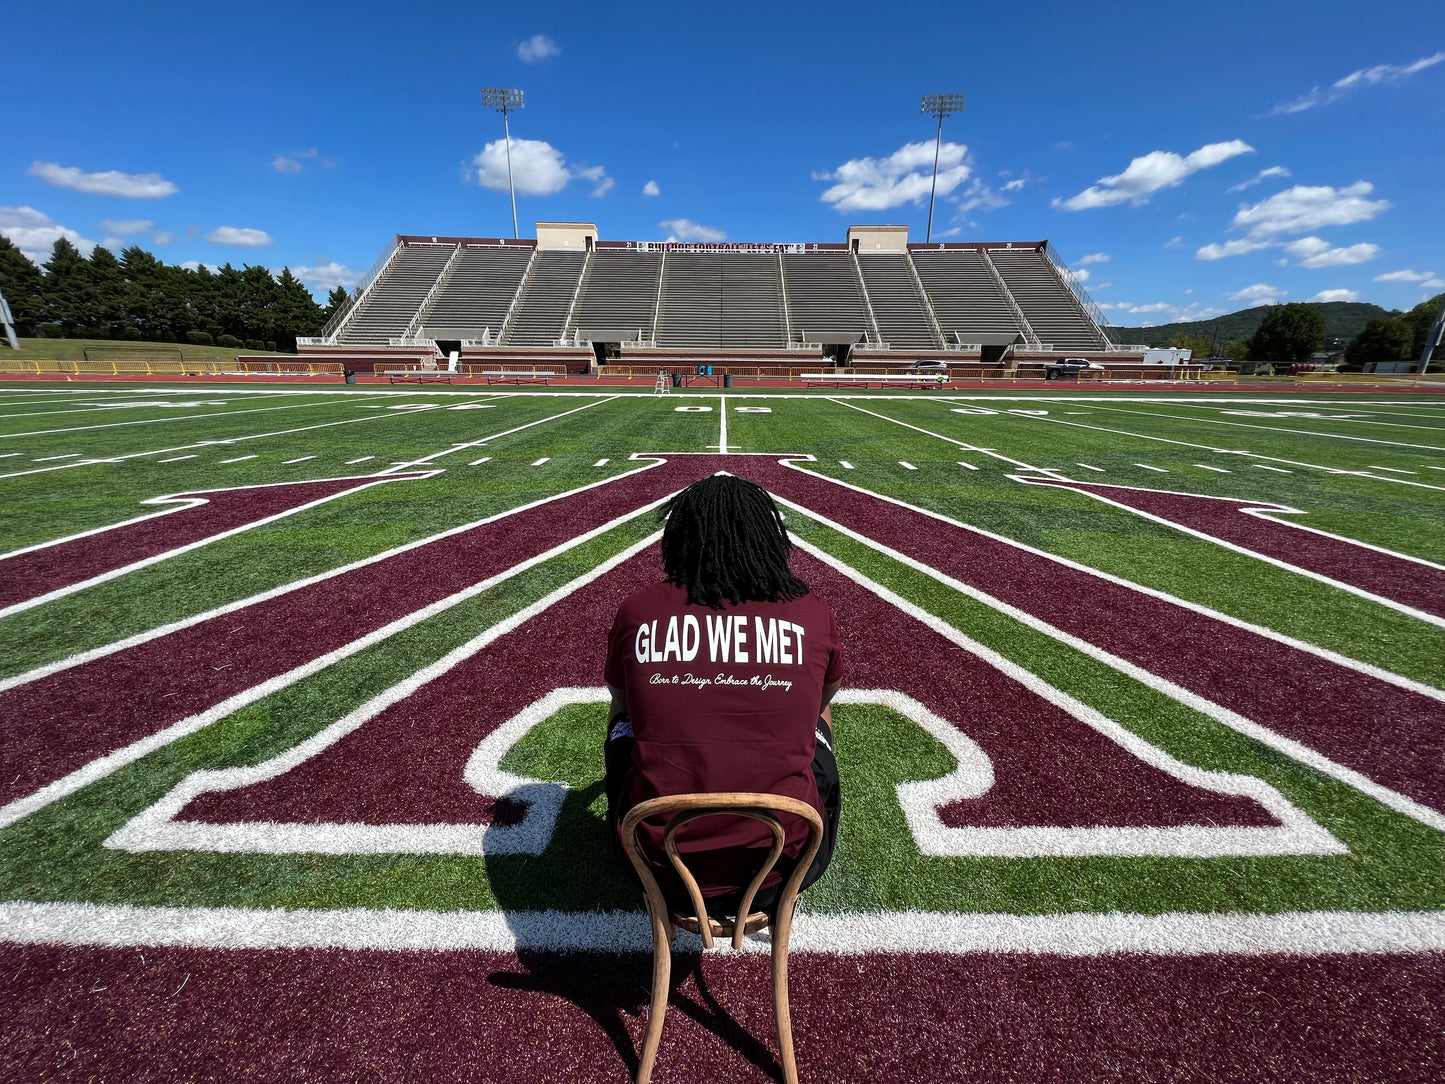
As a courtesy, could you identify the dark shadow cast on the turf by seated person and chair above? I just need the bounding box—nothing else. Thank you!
[486,774,782,1080]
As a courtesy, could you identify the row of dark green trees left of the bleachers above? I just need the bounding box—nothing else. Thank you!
[0,236,348,353]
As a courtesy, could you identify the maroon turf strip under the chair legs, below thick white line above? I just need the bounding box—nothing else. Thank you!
[0,945,1445,1084]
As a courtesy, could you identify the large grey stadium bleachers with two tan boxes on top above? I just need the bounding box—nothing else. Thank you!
[313,223,1120,364]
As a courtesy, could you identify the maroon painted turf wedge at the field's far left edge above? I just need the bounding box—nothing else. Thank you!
[0,474,425,607]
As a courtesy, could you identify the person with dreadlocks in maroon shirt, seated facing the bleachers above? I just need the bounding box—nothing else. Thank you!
[604,474,842,915]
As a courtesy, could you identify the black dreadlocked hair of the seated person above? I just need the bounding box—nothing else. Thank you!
[662,474,808,610]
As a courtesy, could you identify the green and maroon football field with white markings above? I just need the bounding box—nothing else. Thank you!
[0,383,1445,1081]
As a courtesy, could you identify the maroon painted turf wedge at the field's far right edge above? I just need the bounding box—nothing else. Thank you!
[1020,478,1445,617]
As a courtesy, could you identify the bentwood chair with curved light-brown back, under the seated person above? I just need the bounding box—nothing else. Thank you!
[621,793,822,1084]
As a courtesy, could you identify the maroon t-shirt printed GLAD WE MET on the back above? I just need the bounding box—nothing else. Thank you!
[604,582,842,895]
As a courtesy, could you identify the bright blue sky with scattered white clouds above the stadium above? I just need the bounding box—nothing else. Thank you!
[0,0,1445,325]
